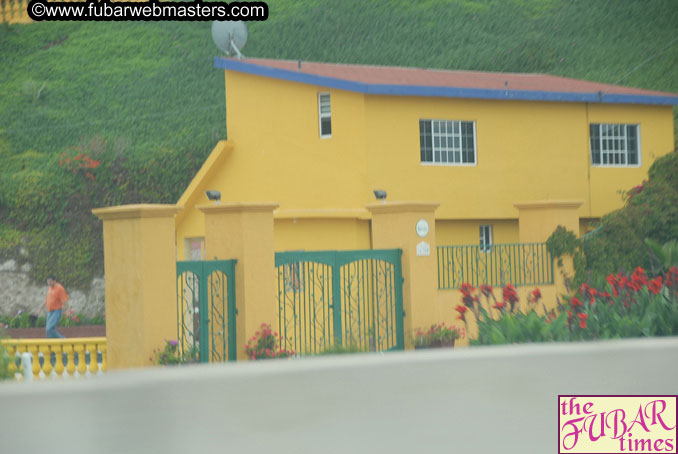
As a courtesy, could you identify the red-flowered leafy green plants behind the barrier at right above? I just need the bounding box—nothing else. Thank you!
[457,267,678,345]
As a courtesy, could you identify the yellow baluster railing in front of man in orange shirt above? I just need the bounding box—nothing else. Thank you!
[0,337,106,380]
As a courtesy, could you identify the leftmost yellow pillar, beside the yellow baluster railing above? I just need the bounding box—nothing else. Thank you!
[92,205,179,369]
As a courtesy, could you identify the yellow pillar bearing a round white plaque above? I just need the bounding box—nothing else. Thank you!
[366,202,443,348]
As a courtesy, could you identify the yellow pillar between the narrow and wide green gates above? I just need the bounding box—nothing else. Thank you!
[198,203,278,359]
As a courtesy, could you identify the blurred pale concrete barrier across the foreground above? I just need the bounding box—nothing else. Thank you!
[0,338,678,454]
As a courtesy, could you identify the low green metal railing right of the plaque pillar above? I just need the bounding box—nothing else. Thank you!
[438,243,553,289]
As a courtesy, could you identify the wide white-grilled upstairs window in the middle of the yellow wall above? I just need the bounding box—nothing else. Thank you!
[419,120,476,165]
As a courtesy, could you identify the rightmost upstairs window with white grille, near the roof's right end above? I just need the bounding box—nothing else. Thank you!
[590,123,640,166]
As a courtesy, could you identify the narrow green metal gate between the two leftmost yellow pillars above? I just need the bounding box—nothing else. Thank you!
[177,260,237,363]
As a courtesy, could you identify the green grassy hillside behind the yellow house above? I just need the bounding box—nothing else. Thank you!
[0,0,678,286]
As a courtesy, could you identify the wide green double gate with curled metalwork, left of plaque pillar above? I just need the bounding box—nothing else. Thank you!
[275,249,405,354]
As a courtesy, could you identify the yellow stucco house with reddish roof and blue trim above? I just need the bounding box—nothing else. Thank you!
[176,58,678,260]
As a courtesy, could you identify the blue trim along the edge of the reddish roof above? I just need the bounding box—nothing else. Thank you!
[214,57,678,105]
